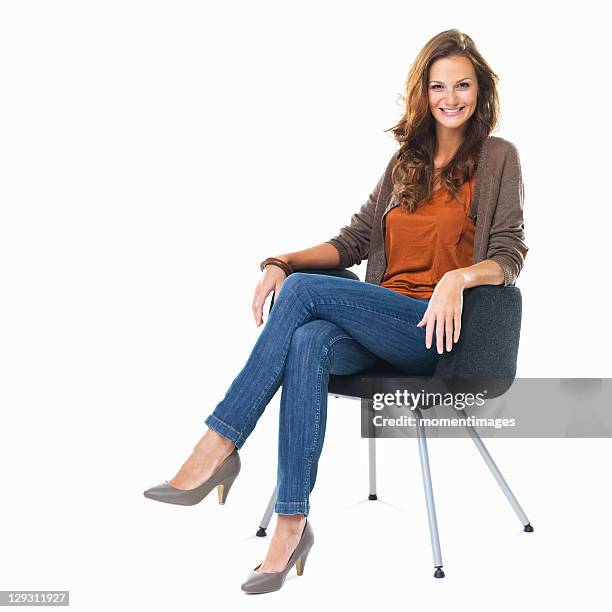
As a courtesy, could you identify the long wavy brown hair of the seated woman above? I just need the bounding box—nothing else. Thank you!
[385,29,500,212]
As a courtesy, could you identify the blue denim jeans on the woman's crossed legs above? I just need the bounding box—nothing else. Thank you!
[205,272,439,515]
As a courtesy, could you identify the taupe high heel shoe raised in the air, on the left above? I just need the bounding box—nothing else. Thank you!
[144,448,240,506]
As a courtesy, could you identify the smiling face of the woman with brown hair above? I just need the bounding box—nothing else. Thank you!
[428,55,478,134]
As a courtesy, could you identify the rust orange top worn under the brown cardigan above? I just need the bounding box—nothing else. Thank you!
[380,174,476,300]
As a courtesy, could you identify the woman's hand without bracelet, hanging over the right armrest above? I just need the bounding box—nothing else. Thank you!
[417,270,466,354]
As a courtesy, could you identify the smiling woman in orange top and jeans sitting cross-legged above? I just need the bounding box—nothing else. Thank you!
[145,30,528,593]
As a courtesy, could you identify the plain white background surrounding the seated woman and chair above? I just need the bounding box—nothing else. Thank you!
[0,0,612,611]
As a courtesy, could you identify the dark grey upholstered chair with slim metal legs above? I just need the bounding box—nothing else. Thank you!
[257,268,533,578]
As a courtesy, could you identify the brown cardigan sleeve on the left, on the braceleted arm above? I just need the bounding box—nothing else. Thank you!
[327,152,397,268]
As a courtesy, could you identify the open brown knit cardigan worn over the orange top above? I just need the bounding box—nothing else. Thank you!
[327,136,529,285]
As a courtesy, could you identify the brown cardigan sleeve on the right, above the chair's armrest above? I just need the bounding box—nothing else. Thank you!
[487,143,529,286]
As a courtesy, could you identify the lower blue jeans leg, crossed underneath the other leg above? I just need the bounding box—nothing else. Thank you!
[274,319,384,515]
